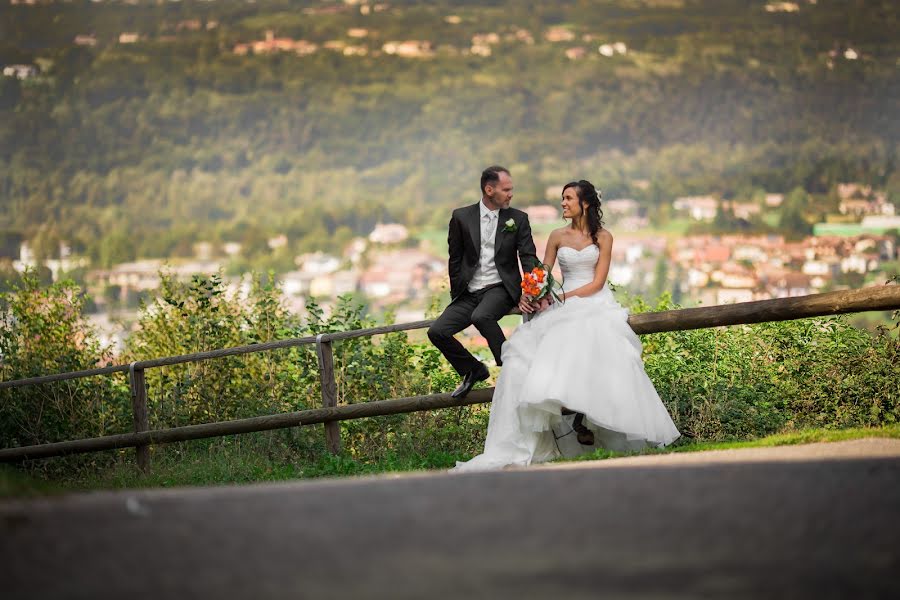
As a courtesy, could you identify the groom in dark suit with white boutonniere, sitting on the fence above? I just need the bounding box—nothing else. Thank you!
[428,166,538,398]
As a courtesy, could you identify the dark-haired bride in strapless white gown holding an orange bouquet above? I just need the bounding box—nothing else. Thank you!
[454,180,679,471]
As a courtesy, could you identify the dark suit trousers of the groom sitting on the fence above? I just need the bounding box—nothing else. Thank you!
[428,283,515,375]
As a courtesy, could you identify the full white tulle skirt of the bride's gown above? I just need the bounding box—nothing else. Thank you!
[455,287,679,471]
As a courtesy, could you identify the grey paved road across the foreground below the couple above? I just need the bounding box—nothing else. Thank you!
[0,440,900,599]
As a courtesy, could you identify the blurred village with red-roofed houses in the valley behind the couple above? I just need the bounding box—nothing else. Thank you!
[14,183,900,354]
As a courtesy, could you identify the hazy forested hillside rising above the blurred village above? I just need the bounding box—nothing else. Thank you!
[0,0,900,264]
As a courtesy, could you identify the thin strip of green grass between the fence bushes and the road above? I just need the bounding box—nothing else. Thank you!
[0,424,900,498]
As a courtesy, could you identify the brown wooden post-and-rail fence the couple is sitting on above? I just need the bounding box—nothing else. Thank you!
[0,285,900,470]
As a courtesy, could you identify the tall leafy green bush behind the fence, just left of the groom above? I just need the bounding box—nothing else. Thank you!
[128,275,487,461]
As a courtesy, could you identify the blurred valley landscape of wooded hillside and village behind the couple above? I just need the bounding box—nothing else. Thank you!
[0,0,900,348]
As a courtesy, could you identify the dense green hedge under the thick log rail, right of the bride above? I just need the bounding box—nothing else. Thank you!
[632,297,900,440]
